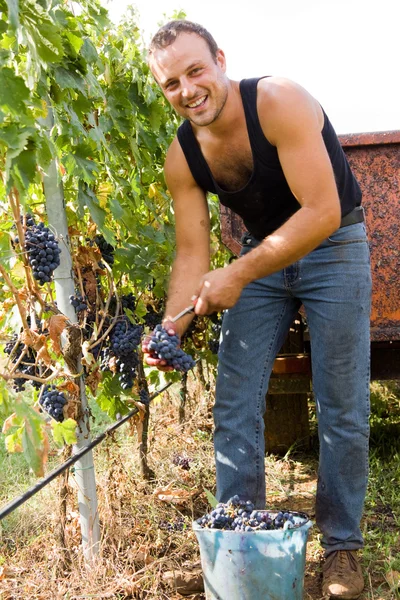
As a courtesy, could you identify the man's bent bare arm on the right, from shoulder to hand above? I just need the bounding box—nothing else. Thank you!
[196,78,341,314]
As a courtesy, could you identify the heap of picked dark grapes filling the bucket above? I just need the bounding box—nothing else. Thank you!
[196,496,298,531]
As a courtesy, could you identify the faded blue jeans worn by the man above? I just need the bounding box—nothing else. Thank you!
[214,223,371,554]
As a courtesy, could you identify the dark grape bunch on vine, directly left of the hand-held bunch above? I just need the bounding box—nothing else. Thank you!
[109,316,143,390]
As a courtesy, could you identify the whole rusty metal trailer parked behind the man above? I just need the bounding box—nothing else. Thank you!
[221,131,400,453]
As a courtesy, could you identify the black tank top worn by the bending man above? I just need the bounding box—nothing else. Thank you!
[178,77,361,240]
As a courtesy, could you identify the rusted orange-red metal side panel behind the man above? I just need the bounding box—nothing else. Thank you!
[221,131,400,342]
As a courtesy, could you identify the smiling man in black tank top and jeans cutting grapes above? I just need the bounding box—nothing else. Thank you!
[146,20,371,599]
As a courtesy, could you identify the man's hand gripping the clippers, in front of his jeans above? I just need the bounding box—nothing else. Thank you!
[193,265,244,315]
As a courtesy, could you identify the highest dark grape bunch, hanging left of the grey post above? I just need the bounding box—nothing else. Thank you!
[21,215,61,285]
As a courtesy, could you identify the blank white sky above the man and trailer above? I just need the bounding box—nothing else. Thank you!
[102,0,400,133]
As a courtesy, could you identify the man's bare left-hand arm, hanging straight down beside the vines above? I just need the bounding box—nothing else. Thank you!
[165,139,210,335]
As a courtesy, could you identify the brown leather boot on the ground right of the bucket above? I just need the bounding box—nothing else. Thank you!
[322,550,364,600]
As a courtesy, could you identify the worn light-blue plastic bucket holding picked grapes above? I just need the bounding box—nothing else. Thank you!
[192,510,312,600]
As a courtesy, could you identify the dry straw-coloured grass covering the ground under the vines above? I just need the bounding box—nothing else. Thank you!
[0,379,396,600]
